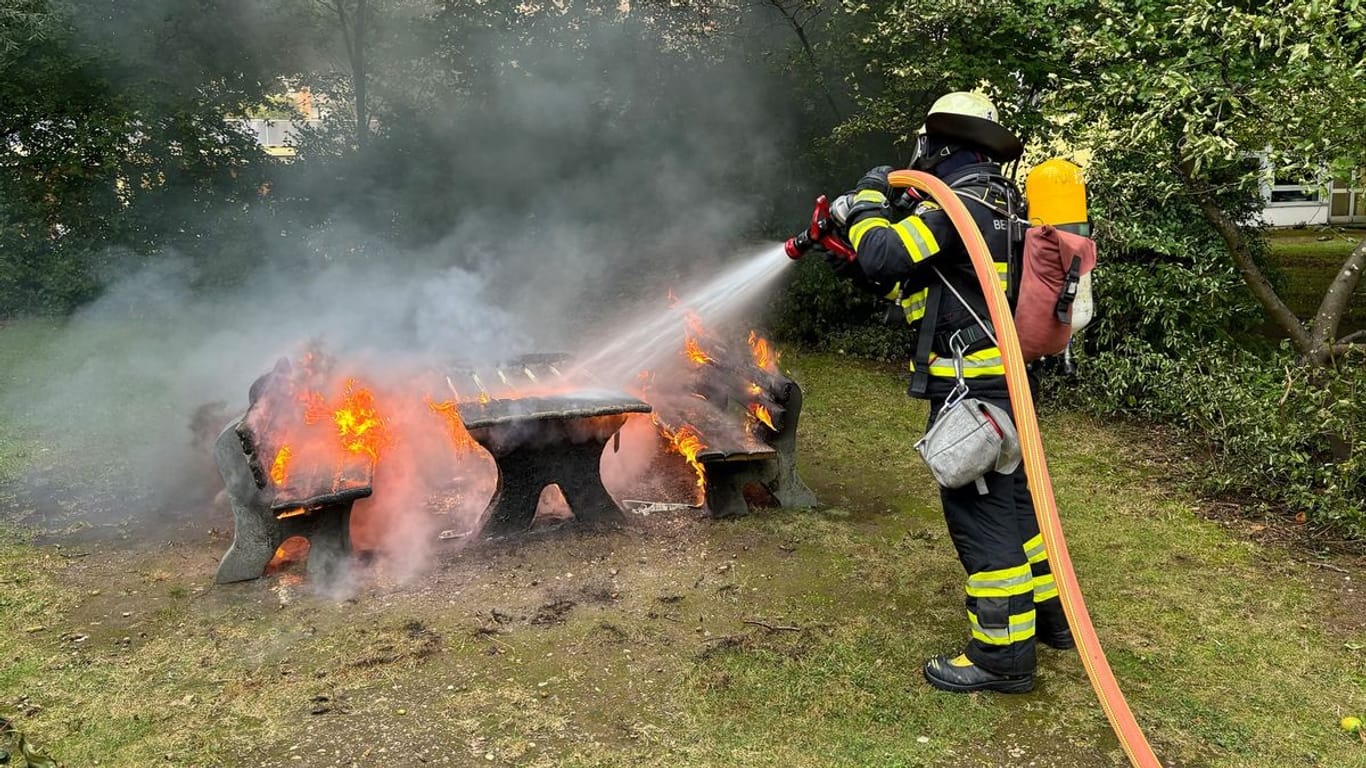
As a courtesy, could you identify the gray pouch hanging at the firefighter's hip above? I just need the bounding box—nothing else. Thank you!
[915,398,1020,495]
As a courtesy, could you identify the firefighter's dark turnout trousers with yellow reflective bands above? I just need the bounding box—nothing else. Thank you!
[930,387,1067,675]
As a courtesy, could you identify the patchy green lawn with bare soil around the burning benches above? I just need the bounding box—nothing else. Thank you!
[0,344,1366,768]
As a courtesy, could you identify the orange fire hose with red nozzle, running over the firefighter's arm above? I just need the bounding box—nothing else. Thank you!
[787,171,1161,768]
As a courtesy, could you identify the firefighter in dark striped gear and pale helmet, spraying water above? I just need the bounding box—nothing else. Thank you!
[831,92,1075,693]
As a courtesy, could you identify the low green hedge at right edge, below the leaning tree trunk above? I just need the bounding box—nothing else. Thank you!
[1067,344,1366,537]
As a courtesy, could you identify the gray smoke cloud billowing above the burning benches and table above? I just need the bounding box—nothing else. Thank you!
[0,2,808,584]
